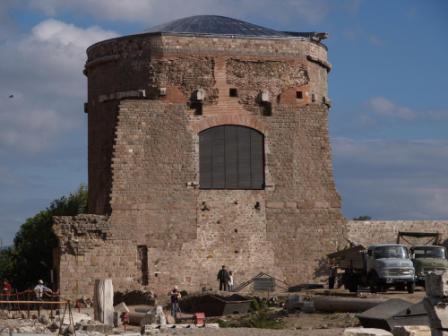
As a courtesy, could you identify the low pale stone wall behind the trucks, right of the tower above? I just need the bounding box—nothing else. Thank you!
[347,220,448,246]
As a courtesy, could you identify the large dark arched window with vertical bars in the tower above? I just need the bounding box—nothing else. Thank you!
[199,125,264,189]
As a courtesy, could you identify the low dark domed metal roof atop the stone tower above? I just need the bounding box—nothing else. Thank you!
[148,15,289,37]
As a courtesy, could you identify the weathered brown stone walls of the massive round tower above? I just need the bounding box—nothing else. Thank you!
[55,16,344,297]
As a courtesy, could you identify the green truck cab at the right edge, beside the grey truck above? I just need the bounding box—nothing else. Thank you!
[411,245,448,286]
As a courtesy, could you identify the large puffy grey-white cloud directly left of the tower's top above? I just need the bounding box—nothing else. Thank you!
[0,19,116,153]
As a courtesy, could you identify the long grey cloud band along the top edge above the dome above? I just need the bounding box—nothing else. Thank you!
[28,0,336,28]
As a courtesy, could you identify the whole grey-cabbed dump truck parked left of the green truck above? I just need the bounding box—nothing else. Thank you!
[328,244,415,293]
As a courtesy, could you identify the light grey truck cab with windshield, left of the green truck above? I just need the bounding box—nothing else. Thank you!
[364,244,415,293]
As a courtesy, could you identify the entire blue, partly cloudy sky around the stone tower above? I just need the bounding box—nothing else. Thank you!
[0,0,448,244]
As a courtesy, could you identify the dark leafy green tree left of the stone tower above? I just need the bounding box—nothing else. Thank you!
[0,185,87,289]
